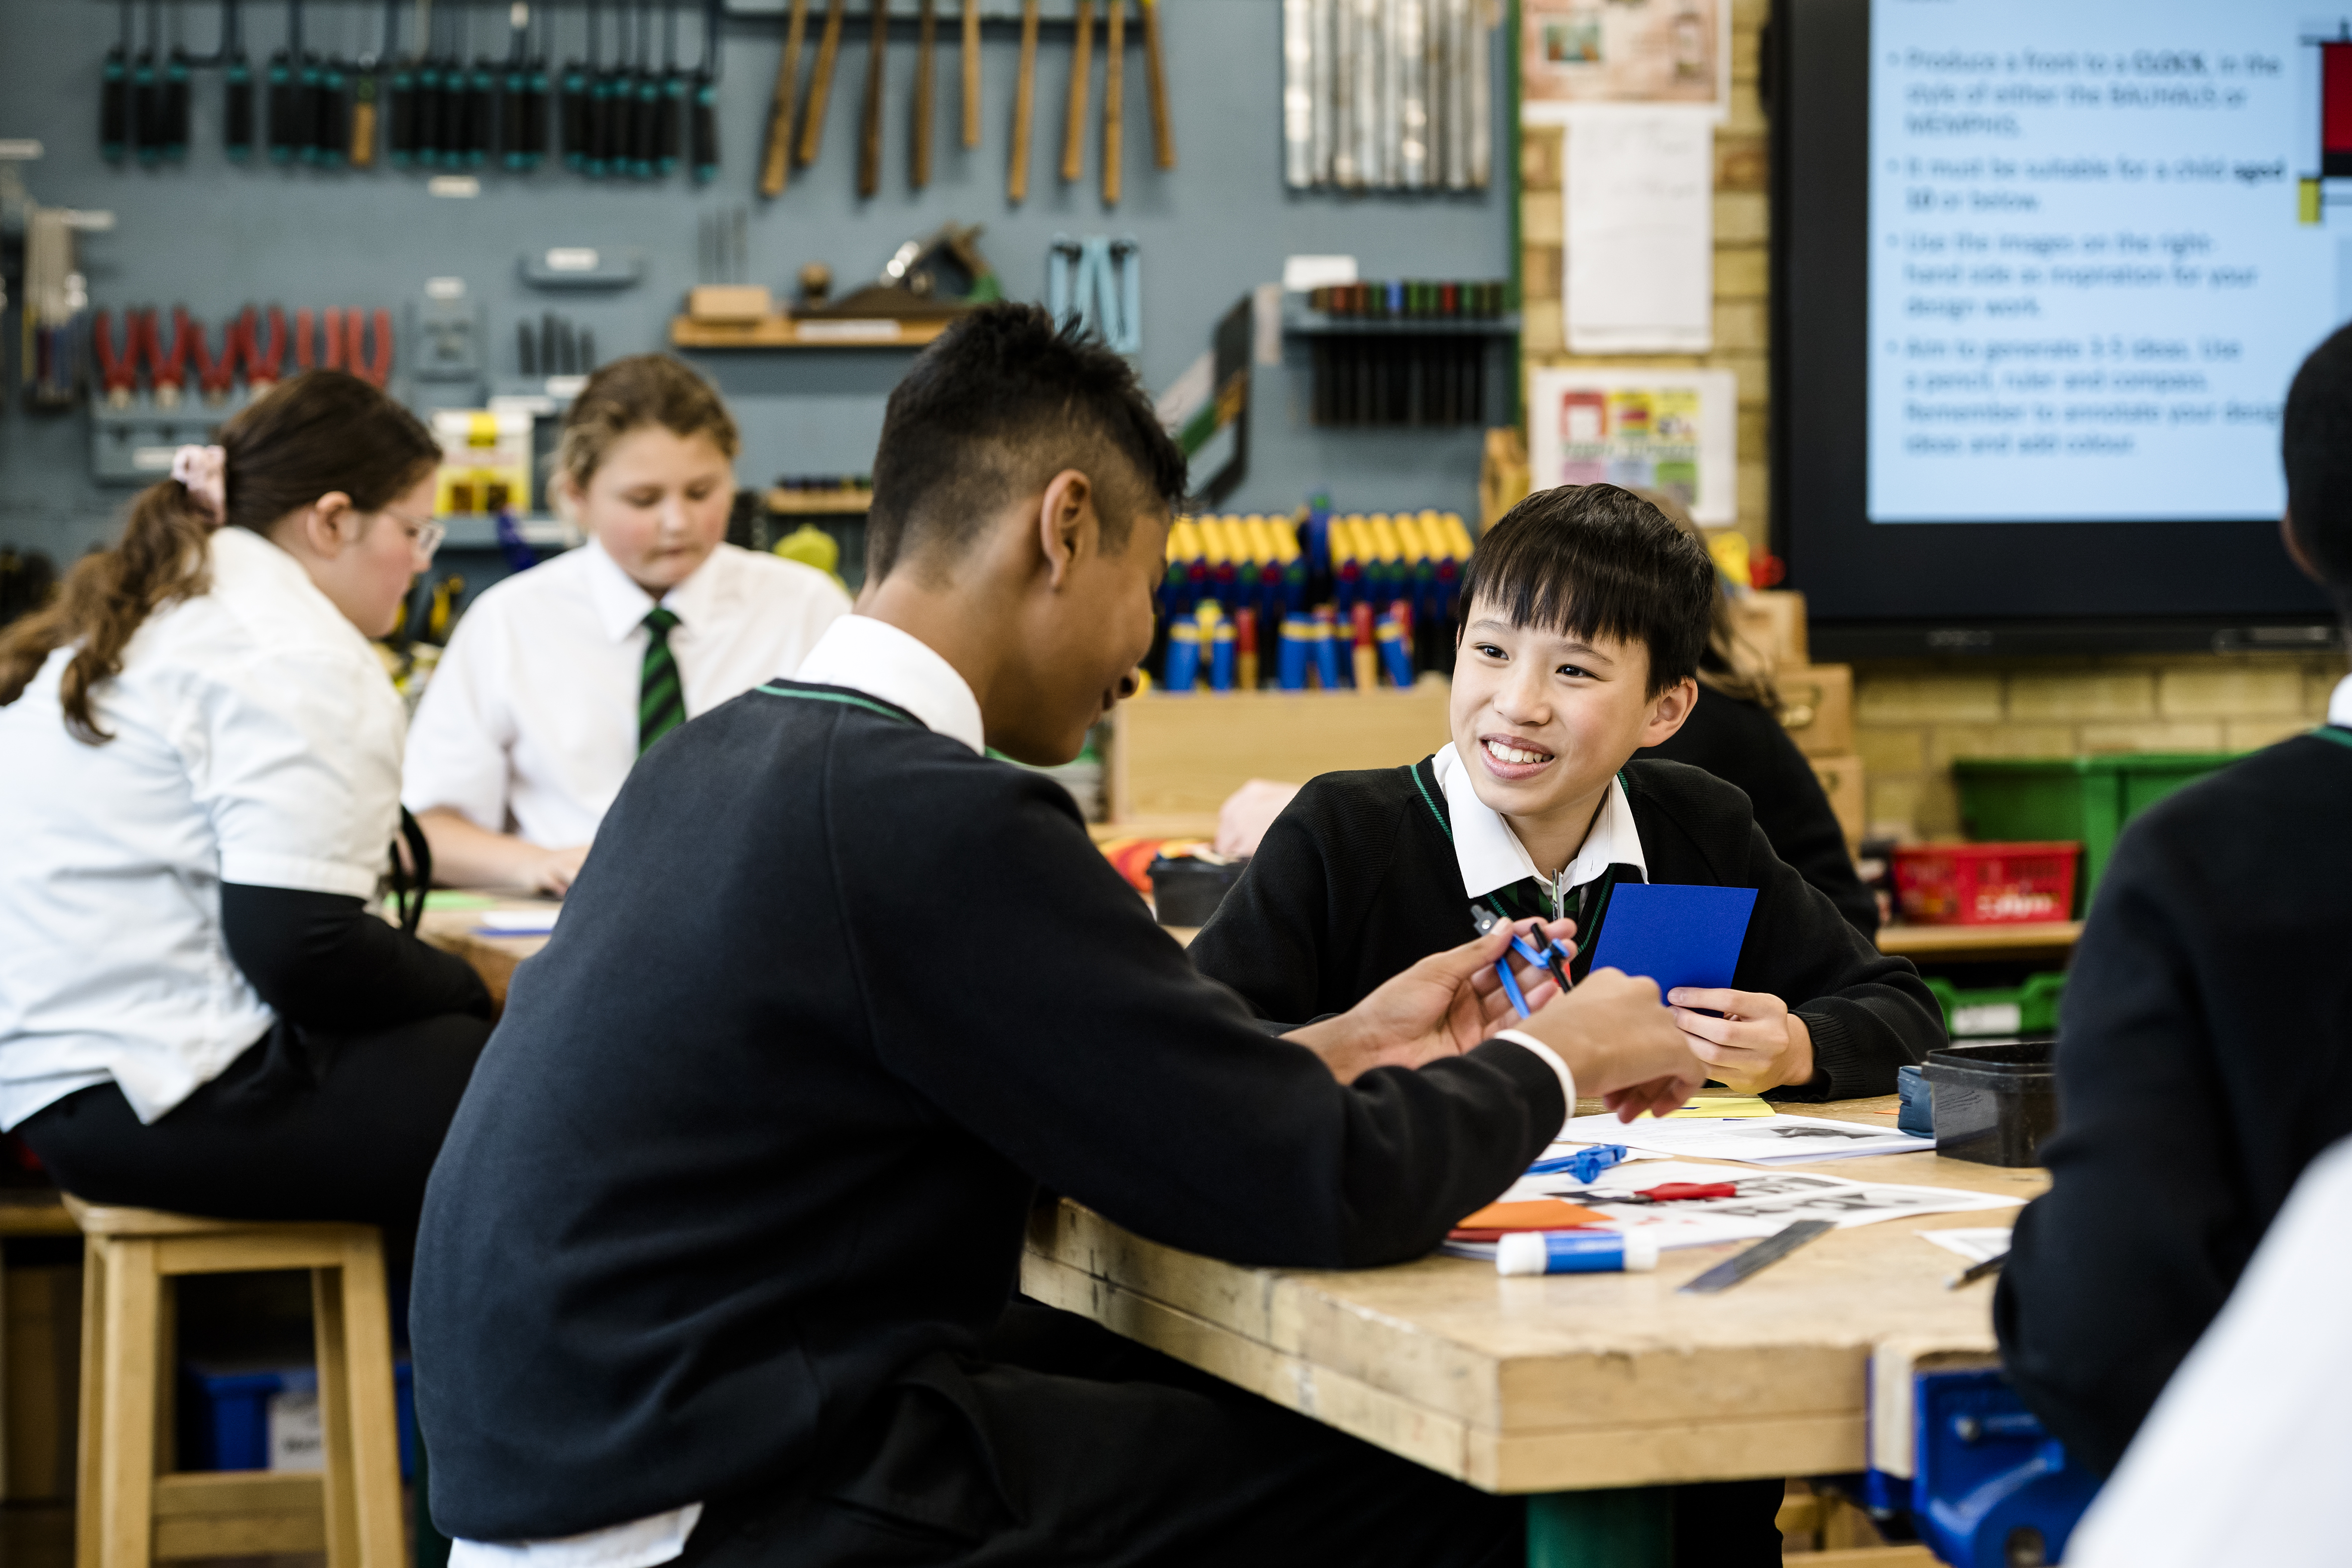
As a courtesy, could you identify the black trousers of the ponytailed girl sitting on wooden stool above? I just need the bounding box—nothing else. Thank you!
[16,1013,489,1269]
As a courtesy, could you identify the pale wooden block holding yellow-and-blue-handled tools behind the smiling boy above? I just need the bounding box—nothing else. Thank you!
[1110,679,1449,823]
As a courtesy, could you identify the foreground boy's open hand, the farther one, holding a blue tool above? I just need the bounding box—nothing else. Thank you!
[1284,919,1580,1084]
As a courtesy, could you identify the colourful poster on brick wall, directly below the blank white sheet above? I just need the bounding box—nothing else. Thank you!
[1527,367,1741,527]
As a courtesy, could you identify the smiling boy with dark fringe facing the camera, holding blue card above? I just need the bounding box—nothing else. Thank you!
[1192,484,1945,1568]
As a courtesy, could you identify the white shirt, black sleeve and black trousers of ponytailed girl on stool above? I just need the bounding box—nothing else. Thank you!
[0,529,489,1250]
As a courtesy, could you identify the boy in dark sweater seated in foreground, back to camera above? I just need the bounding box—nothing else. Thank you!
[412,306,1698,1568]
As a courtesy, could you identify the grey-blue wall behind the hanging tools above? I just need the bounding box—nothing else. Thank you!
[0,0,1515,564]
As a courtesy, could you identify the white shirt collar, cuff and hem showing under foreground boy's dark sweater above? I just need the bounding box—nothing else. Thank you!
[449,616,1576,1568]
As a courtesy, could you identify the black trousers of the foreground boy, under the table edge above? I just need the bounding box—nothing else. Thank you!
[678,1302,1780,1568]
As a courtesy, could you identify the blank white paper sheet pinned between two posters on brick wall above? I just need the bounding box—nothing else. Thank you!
[1562,111,1715,355]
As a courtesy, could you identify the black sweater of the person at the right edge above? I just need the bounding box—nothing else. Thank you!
[1995,729,2352,1471]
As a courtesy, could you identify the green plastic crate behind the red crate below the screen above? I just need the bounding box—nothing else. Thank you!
[1952,752,2241,919]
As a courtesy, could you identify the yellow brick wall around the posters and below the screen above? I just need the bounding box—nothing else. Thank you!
[1520,0,2345,837]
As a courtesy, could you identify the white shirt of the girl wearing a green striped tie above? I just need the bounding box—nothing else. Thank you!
[400,541,849,849]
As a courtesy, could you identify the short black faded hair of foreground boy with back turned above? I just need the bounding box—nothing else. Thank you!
[865,303,1185,580]
